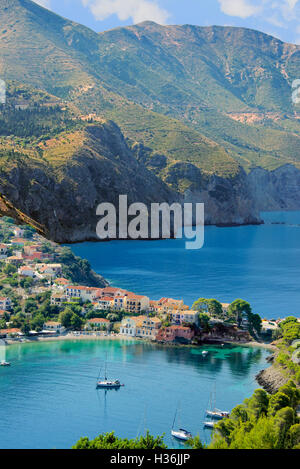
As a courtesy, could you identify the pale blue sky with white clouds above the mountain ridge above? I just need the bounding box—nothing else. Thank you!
[35,0,300,44]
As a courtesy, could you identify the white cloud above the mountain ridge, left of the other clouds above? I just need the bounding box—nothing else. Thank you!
[82,0,170,24]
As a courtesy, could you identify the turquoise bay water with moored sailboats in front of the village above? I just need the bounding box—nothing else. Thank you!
[0,340,268,448]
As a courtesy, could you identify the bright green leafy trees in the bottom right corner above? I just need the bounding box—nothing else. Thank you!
[209,381,300,449]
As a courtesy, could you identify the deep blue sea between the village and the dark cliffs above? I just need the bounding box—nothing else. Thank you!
[72,212,300,318]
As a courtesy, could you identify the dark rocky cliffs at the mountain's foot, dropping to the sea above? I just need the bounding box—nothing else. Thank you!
[0,122,259,242]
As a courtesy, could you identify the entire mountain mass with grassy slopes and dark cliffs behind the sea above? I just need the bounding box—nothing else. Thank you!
[0,0,300,241]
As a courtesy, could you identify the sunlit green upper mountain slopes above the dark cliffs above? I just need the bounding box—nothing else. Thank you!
[0,0,300,176]
